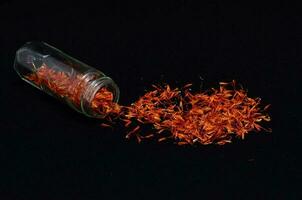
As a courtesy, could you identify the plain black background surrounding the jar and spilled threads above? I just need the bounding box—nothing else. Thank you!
[0,1,302,199]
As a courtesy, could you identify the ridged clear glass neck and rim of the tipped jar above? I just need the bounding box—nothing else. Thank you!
[81,76,120,118]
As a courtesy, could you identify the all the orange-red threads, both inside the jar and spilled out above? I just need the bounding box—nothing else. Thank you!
[27,66,270,145]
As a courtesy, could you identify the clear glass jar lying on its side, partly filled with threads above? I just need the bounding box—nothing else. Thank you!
[14,42,119,118]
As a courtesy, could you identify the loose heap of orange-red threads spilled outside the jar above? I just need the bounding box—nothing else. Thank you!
[125,82,270,145]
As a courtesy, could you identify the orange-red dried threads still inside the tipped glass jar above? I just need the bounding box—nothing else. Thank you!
[27,64,120,115]
